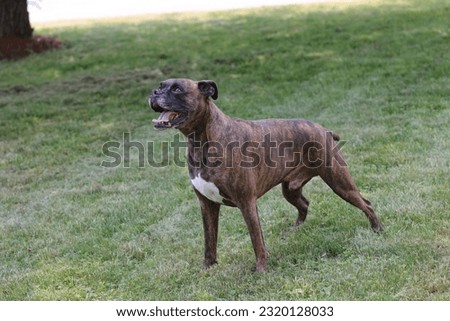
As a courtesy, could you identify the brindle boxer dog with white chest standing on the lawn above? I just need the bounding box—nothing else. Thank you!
[148,79,382,272]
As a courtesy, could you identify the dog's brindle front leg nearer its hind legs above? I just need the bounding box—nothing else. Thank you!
[239,199,269,272]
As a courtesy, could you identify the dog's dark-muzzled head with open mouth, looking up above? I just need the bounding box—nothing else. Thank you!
[148,79,218,130]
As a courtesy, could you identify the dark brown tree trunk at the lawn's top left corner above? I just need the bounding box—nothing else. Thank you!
[0,0,33,39]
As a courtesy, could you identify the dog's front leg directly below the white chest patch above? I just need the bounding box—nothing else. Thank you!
[194,188,220,269]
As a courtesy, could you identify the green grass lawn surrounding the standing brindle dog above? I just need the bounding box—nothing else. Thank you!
[0,0,450,300]
